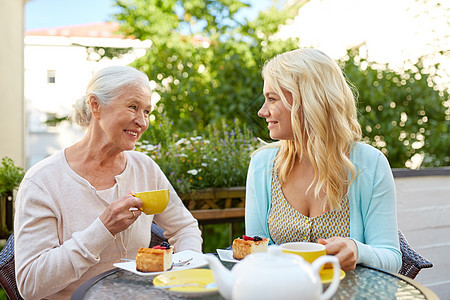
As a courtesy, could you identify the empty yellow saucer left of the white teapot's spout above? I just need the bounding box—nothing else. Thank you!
[153,269,218,297]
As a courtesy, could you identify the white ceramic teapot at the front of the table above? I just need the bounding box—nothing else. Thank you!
[205,245,341,300]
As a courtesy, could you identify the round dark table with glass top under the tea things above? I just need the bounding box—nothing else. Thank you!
[72,262,439,300]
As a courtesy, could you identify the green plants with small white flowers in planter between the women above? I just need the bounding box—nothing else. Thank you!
[136,116,260,193]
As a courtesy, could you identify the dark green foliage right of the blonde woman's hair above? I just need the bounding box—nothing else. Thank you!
[341,49,450,168]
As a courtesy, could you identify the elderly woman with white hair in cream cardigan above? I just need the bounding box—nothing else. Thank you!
[14,66,202,299]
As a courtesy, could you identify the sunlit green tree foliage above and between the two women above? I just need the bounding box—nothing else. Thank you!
[112,0,298,135]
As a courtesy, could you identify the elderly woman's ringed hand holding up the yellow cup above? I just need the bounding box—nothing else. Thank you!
[100,195,142,235]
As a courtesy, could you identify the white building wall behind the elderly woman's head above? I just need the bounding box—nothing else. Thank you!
[25,35,148,168]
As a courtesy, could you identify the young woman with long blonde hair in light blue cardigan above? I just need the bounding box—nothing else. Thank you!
[245,49,401,272]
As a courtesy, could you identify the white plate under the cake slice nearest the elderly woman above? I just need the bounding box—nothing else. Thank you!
[113,250,208,276]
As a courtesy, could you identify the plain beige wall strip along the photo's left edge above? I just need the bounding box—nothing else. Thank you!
[0,0,25,166]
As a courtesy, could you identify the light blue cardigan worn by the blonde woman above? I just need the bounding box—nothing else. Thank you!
[245,143,402,273]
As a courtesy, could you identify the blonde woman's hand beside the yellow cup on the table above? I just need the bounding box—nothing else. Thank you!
[318,237,358,271]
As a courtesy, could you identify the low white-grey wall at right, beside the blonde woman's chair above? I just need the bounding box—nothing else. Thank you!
[394,168,450,299]
